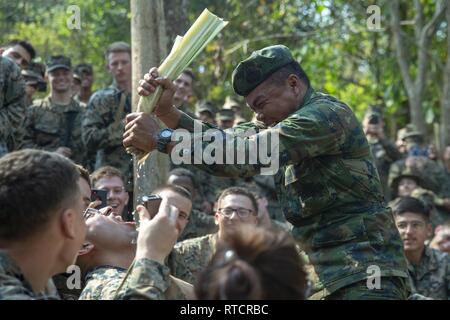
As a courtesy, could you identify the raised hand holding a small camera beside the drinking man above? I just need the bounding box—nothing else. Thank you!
[136,198,178,264]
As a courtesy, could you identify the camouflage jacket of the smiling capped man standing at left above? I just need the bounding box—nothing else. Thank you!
[23,96,86,165]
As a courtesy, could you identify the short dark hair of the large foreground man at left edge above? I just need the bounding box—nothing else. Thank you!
[0,149,80,240]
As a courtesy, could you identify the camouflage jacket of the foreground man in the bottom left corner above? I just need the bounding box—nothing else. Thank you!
[0,251,59,300]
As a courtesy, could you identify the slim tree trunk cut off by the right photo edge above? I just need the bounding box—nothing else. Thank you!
[440,6,450,150]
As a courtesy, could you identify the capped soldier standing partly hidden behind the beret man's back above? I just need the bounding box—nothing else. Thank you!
[363,108,402,200]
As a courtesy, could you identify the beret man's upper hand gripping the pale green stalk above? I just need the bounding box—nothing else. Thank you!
[138,68,176,117]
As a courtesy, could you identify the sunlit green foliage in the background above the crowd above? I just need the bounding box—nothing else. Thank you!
[0,0,447,136]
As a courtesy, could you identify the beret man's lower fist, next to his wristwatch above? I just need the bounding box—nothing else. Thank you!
[123,112,160,152]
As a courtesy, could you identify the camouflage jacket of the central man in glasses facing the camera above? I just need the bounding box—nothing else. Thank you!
[168,233,217,285]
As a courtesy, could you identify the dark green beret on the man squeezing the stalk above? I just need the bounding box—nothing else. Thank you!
[231,45,295,96]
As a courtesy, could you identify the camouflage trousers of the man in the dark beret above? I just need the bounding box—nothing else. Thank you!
[325,277,410,300]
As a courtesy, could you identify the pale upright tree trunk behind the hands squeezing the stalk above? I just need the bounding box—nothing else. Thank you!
[131,0,170,206]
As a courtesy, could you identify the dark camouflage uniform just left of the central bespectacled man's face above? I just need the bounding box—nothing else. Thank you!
[178,209,218,242]
